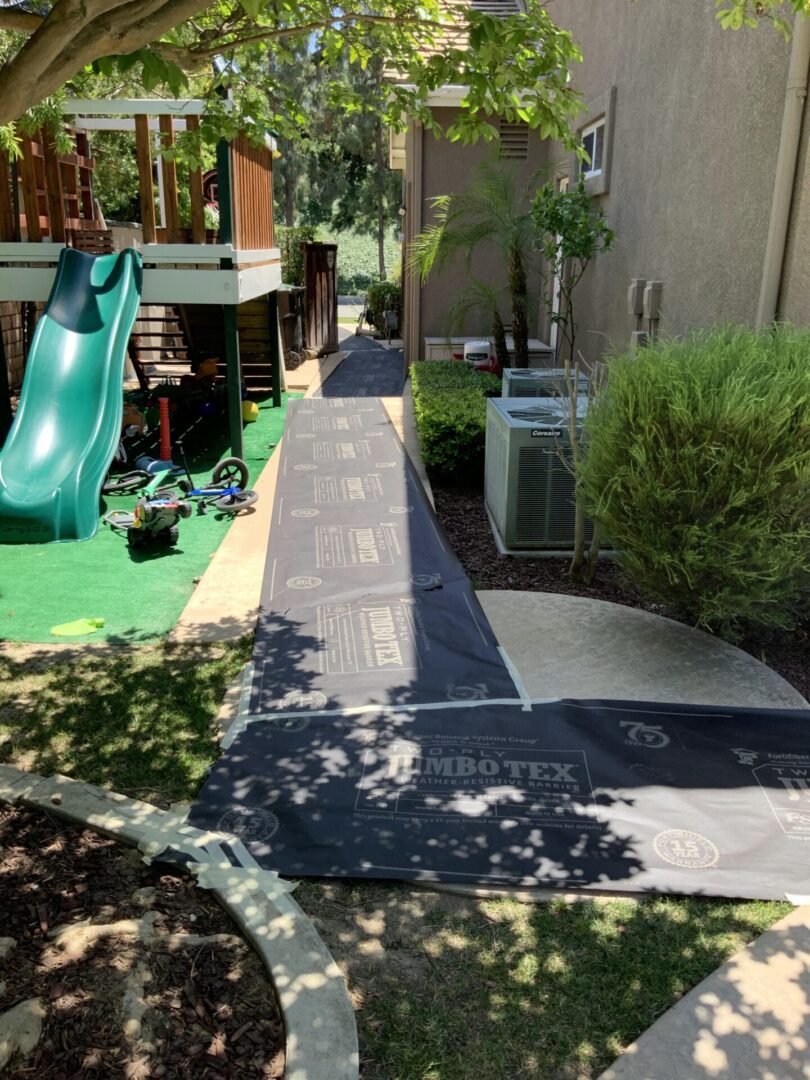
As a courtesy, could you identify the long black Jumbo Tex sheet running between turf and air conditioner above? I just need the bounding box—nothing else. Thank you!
[251,397,517,713]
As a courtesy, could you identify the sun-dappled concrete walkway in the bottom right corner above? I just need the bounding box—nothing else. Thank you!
[600,907,810,1080]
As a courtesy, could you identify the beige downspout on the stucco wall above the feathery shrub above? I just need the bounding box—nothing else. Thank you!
[756,15,810,326]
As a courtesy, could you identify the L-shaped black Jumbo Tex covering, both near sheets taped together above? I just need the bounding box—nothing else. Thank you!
[190,399,810,900]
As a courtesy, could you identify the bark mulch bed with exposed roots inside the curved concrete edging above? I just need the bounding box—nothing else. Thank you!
[0,807,284,1080]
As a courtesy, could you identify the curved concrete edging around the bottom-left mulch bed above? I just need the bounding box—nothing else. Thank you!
[0,765,360,1080]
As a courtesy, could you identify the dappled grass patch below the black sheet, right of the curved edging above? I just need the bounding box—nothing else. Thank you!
[296,882,794,1080]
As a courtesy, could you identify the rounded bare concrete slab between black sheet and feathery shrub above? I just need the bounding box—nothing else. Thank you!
[477,590,808,708]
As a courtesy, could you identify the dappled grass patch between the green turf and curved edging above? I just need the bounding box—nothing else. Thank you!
[0,639,251,806]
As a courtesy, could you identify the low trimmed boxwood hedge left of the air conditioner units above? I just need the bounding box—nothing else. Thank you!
[410,360,500,484]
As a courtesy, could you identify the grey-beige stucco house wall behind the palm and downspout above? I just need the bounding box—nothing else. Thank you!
[397,0,810,361]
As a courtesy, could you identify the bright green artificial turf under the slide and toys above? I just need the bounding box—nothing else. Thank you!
[0,394,300,643]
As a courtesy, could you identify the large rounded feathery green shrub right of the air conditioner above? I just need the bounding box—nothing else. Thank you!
[581,328,810,636]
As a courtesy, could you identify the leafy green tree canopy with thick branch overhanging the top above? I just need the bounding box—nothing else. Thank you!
[0,0,810,156]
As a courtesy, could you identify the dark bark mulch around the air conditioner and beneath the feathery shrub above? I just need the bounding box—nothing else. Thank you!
[431,481,810,700]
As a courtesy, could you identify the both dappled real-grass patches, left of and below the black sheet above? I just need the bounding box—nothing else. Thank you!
[0,638,791,1080]
